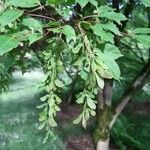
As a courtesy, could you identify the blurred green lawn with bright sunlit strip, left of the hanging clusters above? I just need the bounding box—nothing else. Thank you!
[0,70,66,150]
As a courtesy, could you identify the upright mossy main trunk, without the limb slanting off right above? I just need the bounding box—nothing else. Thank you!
[93,79,113,150]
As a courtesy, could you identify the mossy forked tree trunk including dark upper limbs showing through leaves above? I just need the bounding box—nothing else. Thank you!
[94,0,150,150]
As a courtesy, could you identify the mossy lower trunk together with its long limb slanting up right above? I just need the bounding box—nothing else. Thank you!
[94,60,150,150]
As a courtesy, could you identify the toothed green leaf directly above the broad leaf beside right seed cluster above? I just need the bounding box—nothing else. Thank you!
[91,24,114,44]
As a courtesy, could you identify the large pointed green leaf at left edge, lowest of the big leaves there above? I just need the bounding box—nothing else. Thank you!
[0,35,19,56]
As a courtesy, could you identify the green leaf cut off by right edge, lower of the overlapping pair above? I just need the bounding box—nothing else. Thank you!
[135,35,150,47]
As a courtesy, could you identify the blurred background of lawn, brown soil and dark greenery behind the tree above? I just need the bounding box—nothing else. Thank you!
[0,51,150,150]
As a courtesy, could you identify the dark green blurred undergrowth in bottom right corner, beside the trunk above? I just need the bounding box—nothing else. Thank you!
[111,113,149,150]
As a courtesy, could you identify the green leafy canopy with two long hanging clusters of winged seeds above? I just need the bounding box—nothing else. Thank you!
[0,0,150,144]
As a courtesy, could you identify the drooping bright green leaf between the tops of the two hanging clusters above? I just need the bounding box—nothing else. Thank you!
[62,25,76,42]
